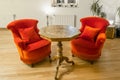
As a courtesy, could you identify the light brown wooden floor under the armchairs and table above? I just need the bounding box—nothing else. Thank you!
[0,30,120,80]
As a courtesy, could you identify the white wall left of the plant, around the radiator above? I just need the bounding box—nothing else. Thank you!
[0,0,91,27]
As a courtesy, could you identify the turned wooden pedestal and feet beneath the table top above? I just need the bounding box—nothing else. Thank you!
[55,41,74,80]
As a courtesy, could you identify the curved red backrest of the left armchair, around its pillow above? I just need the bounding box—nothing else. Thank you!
[7,19,39,36]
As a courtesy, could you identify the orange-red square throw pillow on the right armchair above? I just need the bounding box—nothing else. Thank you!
[80,25,100,41]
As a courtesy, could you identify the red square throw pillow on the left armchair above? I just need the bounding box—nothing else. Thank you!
[19,27,41,44]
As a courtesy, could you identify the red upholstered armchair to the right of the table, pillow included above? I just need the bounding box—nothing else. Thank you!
[71,16,109,62]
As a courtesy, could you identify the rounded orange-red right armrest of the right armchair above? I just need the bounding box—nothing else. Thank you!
[95,33,106,46]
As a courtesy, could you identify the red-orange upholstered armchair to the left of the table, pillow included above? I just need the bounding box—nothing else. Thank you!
[7,19,51,65]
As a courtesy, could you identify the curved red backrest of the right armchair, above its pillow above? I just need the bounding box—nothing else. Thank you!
[80,16,109,32]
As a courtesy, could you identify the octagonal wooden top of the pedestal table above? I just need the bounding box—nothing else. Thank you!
[40,25,80,41]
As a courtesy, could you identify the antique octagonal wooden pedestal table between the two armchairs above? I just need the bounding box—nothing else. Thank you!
[40,25,80,80]
